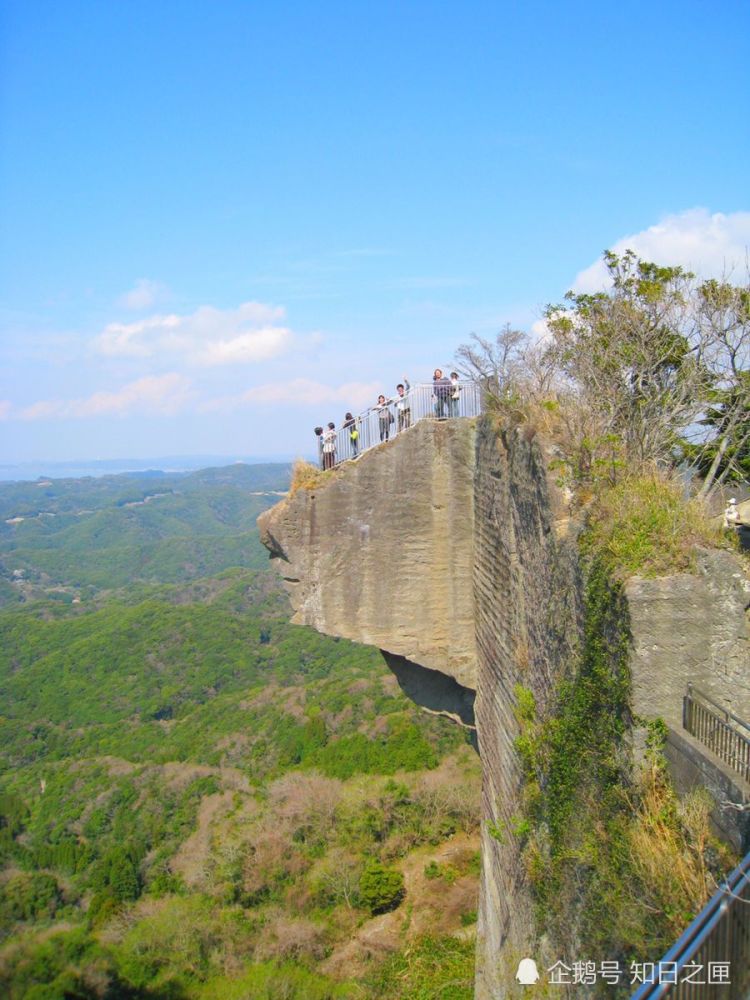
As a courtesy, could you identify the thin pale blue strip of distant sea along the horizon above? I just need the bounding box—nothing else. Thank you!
[0,455,300,482]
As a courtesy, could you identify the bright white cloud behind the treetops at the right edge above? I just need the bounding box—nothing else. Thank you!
[573,208,750,292]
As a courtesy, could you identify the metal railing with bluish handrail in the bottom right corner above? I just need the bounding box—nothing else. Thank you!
[631,854,750,1000]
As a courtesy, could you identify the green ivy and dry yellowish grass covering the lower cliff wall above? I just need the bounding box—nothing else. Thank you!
[514,555,728,980]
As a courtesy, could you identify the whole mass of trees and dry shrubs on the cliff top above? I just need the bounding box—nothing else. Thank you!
[459,251,750,497]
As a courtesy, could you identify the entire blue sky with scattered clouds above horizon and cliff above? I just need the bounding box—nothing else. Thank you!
[0,0,750,462]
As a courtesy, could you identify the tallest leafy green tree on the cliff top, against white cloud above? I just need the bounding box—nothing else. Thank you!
[546,250,710,463]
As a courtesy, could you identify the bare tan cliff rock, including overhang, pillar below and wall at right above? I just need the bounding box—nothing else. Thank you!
[259,417,750,1000]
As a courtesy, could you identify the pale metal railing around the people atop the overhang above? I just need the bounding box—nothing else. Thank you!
[319,381,482,468]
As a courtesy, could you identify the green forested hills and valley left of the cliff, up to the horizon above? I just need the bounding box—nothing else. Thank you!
[0,464,479,1000]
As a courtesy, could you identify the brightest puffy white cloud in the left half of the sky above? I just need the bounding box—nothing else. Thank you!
[94,302,293,367]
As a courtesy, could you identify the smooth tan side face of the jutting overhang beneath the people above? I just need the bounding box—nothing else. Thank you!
[258,420,477,689]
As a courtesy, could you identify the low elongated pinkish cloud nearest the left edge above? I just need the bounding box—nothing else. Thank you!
[18,372,193,420]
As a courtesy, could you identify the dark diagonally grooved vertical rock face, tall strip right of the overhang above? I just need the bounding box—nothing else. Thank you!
[474,419,580,1000]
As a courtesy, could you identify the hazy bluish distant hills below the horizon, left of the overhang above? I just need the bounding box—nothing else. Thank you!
[0,464,290,605]
